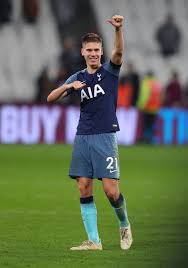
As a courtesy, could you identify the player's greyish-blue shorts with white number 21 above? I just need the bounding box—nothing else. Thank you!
[69,133,120,179]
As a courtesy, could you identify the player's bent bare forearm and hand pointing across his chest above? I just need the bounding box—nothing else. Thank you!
[47,80,86,102]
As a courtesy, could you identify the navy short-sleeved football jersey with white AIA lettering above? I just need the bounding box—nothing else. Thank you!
[65,61,121,135]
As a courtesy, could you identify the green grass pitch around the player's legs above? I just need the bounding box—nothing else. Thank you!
[0,145,188,268]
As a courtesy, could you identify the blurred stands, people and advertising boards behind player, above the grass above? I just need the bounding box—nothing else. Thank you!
[0,0,188,145]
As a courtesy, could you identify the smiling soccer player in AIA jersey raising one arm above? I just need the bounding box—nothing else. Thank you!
[47,15,132,250]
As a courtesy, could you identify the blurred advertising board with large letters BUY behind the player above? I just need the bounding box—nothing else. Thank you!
[0,104,188,145]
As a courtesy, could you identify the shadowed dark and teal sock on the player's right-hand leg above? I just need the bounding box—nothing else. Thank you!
[110,193,129,227]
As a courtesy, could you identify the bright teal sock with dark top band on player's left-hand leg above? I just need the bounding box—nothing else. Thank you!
[80,196,100,243]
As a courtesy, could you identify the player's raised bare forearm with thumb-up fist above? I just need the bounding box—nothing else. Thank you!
[108,15,124,65]
